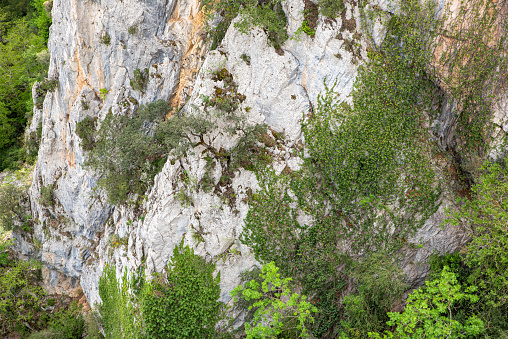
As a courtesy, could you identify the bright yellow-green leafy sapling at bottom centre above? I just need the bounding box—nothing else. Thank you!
[231,262,317,338]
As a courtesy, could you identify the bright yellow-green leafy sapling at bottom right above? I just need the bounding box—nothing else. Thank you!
[370,266,485,338]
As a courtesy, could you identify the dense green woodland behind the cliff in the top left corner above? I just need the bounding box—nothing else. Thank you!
[0,0,51,171]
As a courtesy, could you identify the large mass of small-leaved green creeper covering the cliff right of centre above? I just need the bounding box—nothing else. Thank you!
[242,2,440,337]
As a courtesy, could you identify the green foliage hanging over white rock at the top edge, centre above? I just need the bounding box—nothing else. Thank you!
[203,0,288,49]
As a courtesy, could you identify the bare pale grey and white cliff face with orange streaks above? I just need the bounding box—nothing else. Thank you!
[17,0,506,305]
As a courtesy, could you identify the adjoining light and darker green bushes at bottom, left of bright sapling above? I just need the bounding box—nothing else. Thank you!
[99,242,224,338]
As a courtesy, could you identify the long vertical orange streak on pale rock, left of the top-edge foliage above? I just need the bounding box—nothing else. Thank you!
[169,11,205,108]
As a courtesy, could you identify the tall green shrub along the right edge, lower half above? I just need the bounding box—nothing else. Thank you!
[444,163,508,338]
